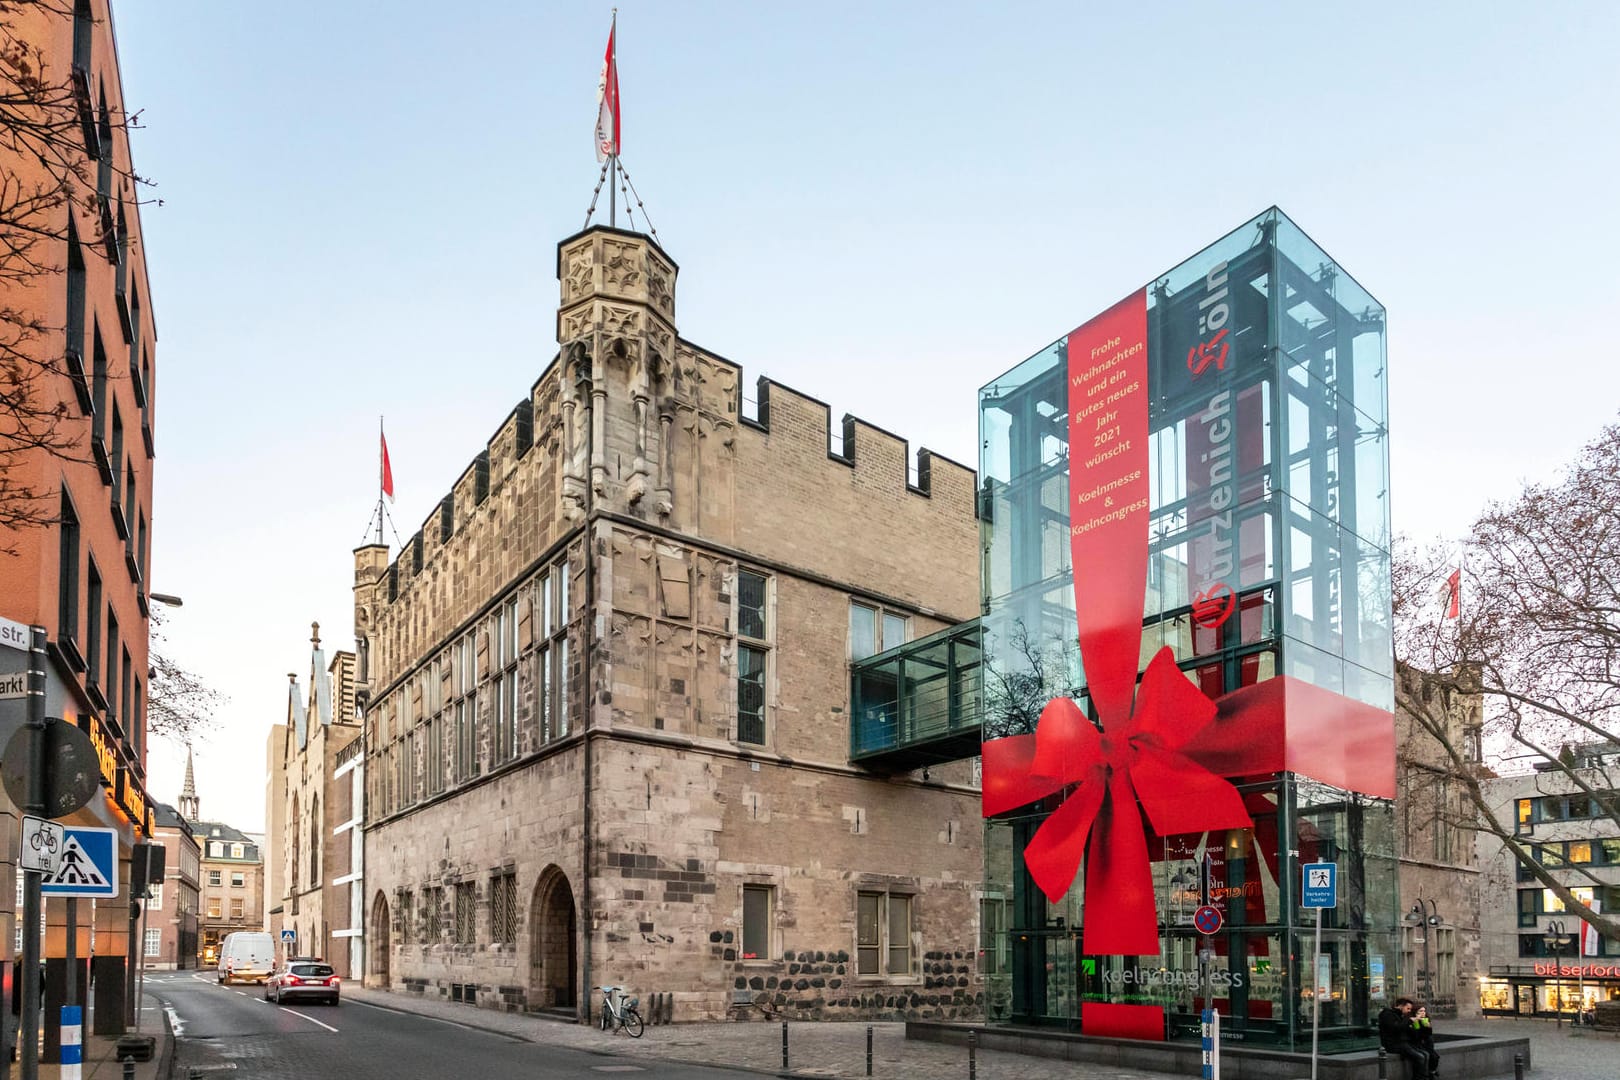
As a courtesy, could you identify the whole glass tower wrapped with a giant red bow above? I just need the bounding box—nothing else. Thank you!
[978,209,1400,1051]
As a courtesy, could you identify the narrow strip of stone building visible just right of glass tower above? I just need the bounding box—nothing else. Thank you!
[1395,680,1484,1018]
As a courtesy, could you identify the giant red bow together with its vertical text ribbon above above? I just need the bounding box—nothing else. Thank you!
[983,291,1252,955]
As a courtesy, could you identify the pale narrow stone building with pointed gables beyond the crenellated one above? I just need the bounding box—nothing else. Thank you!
[266,623,363,978]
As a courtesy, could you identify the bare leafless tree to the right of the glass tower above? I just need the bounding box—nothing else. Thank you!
[1395,423,1620,938]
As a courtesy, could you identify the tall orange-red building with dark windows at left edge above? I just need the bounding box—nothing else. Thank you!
[0,0,156,1033]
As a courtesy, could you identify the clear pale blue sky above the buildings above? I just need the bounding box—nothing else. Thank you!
[115,0,1620,829]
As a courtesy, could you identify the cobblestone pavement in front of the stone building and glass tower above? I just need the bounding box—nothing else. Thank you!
[343,984,1620,1080]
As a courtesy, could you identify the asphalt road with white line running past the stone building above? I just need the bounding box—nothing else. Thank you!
[146,972,745,1080]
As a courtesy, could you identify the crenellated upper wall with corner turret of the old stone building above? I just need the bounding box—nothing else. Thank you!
[355,228,974,687]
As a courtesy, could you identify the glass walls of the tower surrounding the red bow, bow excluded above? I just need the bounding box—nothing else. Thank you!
[978,209,1398,1049]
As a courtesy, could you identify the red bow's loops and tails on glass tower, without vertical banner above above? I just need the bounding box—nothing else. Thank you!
[983,648,1252,955]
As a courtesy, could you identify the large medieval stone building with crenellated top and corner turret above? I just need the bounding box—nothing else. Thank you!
[355,227,980,1020]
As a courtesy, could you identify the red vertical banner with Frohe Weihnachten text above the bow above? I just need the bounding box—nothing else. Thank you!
[1068,290,1149,722]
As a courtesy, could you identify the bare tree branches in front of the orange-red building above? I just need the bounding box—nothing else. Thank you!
[0,0,144,531]
